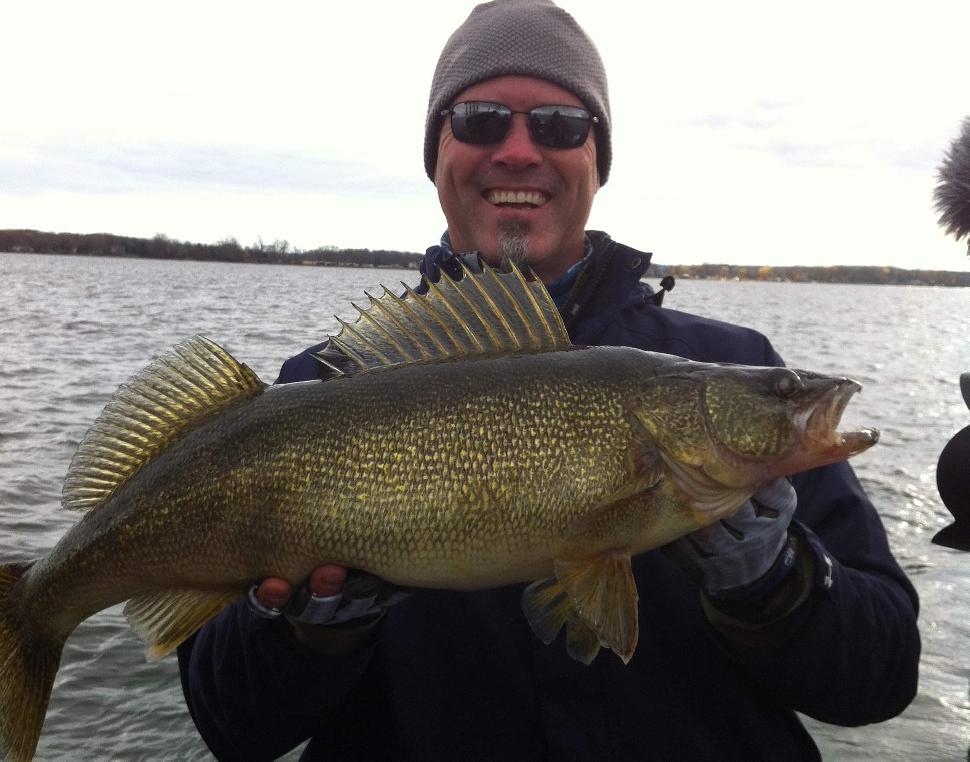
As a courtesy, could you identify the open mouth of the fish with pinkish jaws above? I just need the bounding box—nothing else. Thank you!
[795,374,879,465]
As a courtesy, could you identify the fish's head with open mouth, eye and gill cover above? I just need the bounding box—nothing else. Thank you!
[636,361,879,488]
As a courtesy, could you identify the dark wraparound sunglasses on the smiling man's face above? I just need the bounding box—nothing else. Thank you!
[440,101,599,148]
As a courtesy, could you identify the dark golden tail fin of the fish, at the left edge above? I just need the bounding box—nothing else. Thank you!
[0,564,64,762]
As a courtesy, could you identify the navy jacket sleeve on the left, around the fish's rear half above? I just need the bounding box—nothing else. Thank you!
[178,345,374,760]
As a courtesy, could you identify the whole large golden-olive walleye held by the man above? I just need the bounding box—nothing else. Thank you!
[0,268,877,760]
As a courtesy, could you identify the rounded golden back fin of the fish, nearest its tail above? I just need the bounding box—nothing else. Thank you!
[63,336,266,511]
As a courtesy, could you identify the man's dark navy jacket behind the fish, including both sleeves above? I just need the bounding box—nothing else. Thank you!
[179,233,920,760]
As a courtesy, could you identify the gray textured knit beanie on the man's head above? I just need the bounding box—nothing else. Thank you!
[424,0,613,185]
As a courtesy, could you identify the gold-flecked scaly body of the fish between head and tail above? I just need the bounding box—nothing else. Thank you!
[40,349,652,628]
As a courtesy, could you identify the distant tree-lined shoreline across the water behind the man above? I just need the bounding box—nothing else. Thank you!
[0,230,970,288]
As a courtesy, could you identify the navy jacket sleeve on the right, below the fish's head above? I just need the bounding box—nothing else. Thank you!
[731,463,920,725]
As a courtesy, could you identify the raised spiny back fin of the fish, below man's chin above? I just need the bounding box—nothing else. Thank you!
[319,265,571,371]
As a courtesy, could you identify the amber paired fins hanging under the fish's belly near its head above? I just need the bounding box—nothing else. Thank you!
[522,552,638,664]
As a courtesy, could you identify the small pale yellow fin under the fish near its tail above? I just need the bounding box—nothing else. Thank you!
[125,590,240,661]
